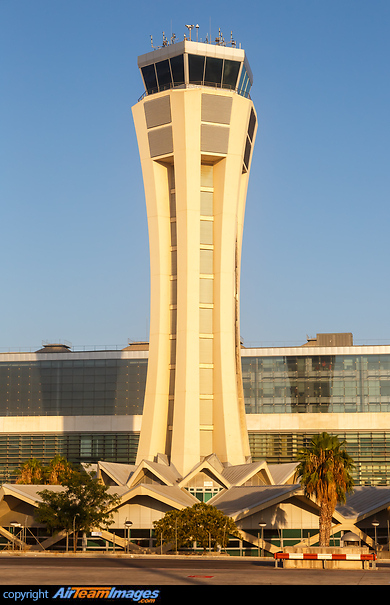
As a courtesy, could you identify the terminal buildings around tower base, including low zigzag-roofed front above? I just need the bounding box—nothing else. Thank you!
[0,334,390,555]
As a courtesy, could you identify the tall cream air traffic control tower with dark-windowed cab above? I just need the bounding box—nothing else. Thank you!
[132,26,257,476]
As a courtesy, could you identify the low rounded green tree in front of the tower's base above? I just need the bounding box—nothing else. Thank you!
[153,502,240,550]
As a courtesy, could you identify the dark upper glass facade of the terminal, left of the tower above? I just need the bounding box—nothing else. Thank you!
[0,359,147,416]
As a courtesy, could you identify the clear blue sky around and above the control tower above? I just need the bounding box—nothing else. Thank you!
[0,0,390,350]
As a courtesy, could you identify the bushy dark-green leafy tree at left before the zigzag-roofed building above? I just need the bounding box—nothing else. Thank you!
[36,470,120,551]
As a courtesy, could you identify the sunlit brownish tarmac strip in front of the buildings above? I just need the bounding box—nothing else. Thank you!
[0,551,390,584]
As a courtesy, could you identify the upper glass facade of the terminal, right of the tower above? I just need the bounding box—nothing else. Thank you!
[242,355,390,414]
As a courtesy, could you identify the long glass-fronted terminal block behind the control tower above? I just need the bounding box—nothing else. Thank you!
[0,334,390,485]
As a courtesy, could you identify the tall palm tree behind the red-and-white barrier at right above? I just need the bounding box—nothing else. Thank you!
[296,433,354,546]
